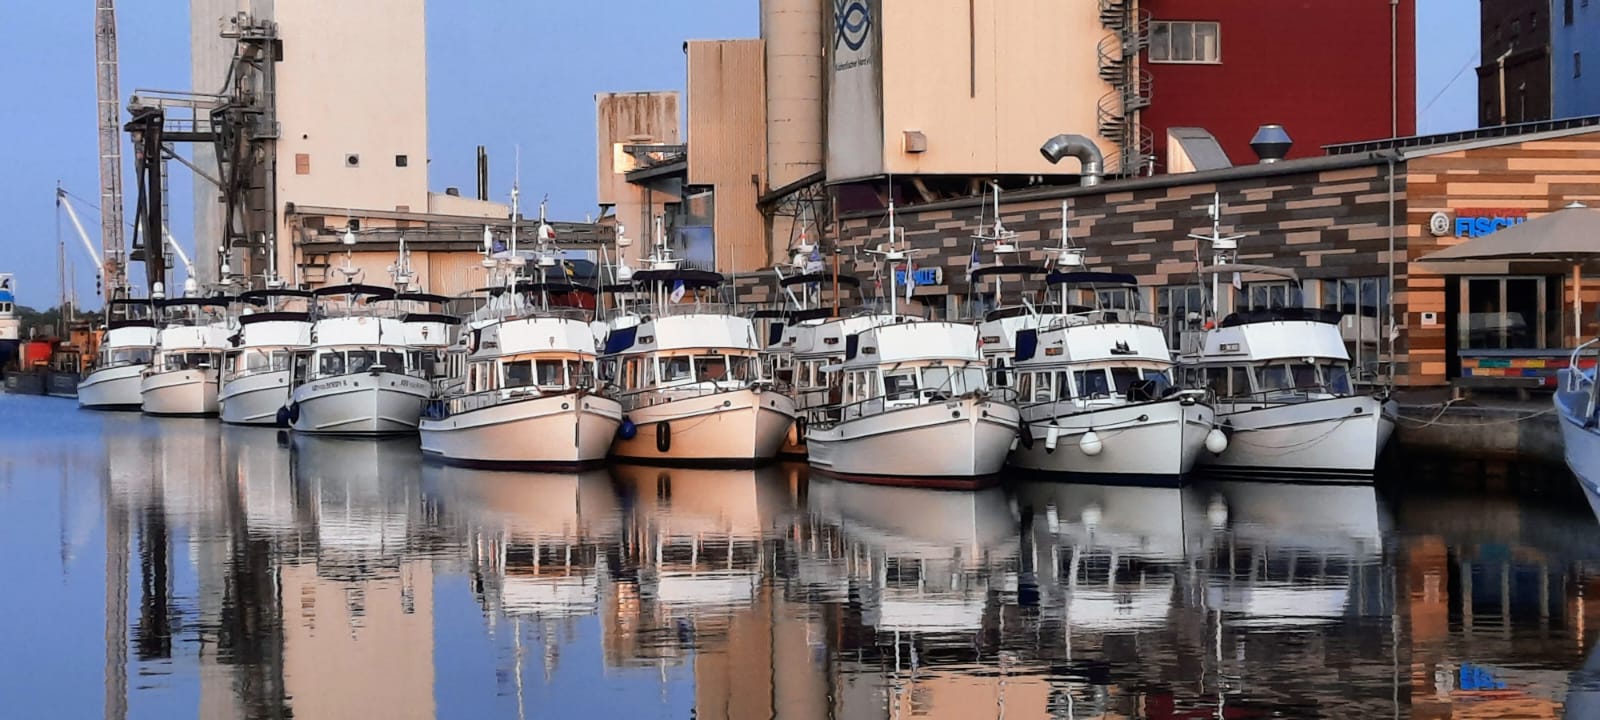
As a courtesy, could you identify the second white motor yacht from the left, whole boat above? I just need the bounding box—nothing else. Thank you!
[139,298,234,414]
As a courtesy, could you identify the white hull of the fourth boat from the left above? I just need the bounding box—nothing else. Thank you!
[290,373,434,435]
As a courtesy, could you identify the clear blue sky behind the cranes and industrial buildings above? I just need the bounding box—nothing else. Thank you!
[0,0,1478,307]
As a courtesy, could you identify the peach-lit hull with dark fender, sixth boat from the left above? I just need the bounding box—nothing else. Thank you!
[611,390,795,466]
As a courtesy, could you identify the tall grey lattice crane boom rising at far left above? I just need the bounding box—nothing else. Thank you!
[94,0,128,298]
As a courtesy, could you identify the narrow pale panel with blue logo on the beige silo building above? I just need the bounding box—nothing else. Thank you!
[827,0,883,181]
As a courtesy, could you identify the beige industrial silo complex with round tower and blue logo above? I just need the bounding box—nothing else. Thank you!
[595,0,1138,272]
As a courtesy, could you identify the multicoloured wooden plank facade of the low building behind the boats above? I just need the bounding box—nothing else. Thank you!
[739,128,1600,386]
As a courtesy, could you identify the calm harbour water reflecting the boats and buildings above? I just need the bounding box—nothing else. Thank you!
[0,390,1600,718]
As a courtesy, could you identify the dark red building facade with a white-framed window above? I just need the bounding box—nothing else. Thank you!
[1139,0,1414,173]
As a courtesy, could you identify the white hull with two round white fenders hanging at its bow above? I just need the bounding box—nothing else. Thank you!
[1008,400,1214,485]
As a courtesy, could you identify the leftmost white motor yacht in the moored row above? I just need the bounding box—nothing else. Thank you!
[78,299,155,410]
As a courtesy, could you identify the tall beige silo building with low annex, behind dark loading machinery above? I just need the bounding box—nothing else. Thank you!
[180,0,602,294]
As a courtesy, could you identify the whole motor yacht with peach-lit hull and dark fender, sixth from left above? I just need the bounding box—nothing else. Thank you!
[605,242,795,466]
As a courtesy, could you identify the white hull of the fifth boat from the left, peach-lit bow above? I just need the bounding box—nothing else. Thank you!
[421,394,622,466]
